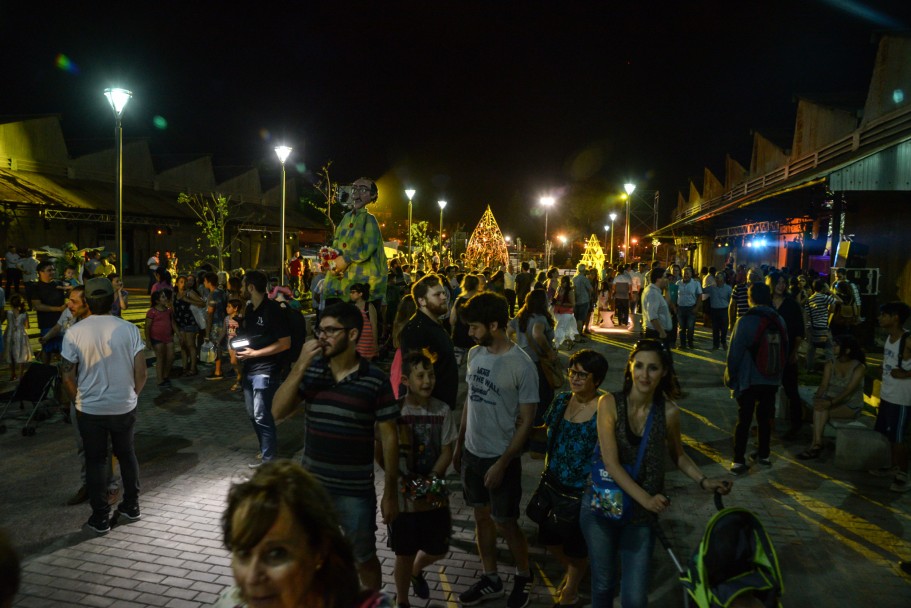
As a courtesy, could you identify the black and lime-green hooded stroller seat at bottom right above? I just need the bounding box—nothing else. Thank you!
[680,508,784,608]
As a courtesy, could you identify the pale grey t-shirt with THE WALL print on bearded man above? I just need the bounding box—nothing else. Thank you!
[465,344,539,458]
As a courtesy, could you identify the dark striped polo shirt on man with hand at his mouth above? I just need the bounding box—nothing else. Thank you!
[298,357,399,496]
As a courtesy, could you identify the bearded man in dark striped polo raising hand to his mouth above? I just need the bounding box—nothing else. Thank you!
[273,302,399,590]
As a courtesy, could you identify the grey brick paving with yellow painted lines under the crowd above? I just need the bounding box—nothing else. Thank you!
[0,300,911,608]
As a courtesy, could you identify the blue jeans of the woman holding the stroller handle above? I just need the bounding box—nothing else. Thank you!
[579,490,655,608]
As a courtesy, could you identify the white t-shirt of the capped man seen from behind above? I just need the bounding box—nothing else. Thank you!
[61,315,145,416]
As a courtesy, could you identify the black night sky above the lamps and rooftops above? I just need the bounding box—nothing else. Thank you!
[0,0,911,241]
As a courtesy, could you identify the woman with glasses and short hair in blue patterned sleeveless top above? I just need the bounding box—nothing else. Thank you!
[538,350,607,606]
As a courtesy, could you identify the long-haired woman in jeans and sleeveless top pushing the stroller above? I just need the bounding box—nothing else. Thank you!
[580,340,732,608]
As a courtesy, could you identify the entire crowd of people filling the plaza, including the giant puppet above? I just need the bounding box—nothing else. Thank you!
[5,178,911,608]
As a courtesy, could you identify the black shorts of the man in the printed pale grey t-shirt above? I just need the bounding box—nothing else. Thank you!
[461,450,522,523]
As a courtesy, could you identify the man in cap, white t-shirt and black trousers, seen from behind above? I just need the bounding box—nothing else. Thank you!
[61,278,146,534]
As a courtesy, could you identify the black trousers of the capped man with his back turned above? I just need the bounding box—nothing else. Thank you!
[76,408,139,516]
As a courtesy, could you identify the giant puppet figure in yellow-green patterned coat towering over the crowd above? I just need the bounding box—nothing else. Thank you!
[323,177,389,319]
